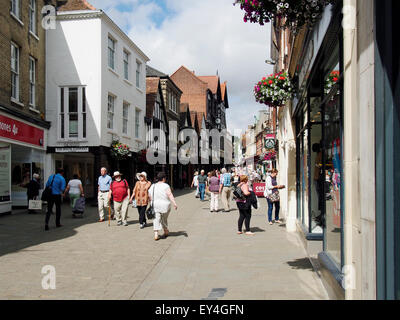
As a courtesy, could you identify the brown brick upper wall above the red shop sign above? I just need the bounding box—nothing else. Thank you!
[0,0,45,119]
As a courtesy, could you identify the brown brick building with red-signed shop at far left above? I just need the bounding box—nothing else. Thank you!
[0,0,50,214]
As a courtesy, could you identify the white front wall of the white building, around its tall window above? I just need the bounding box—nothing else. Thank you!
[46,18,102,146]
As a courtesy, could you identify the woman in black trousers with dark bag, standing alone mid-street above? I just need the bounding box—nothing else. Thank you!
[236,175,254,236]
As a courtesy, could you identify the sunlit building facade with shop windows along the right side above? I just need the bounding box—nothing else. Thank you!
[272,0,400,299]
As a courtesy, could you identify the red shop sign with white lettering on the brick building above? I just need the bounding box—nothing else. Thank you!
[0,115,44,147]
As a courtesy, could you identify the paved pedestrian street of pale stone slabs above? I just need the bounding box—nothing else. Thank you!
[0,190,327,300]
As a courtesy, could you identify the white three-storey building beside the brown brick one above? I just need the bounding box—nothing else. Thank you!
[46,3,149,196]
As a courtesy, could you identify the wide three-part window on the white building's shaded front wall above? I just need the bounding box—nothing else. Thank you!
[59,87,87,140]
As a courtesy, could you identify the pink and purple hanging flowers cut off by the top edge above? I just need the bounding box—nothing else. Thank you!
[234,0,336,32]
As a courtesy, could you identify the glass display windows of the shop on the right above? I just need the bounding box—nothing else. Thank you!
[296,30,343,269]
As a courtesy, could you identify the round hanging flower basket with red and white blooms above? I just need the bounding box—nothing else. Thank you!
[254,72,293,107]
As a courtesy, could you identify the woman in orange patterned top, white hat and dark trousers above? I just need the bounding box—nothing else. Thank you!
[129,172,151,229]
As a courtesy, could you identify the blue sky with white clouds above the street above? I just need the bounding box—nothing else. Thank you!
[88,0,272,133]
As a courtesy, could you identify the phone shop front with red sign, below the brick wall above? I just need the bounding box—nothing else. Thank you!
[0,113,45,214]
